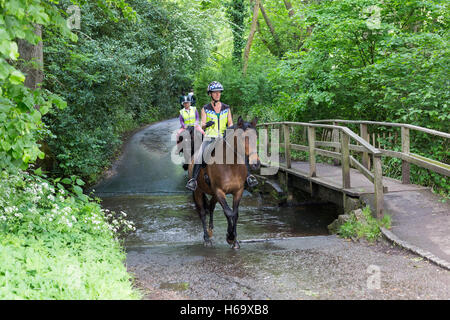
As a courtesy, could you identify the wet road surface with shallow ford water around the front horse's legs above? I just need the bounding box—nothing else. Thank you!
[95,119,450,299]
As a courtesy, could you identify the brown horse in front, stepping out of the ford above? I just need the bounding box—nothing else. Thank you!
[188,117,261,249]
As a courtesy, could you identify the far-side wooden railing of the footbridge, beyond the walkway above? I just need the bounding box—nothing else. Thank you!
[311,119,450,184]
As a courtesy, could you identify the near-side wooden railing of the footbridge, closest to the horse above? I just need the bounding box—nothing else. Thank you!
[258,122,384,218]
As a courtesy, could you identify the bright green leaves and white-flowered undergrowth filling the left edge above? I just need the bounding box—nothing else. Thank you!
[0,0,140,299]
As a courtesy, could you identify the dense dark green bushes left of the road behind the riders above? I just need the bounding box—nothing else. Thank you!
[44,0,212,183]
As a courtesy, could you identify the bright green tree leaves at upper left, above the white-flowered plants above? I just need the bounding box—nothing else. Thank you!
[0,0,133,169]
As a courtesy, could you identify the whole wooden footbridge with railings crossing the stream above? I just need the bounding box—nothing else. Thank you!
[258,120,450,218]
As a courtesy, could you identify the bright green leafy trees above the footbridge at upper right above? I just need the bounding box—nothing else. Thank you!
[272,0,449,124]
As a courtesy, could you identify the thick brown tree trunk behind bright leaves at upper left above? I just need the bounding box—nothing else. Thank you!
[17,25,44,95]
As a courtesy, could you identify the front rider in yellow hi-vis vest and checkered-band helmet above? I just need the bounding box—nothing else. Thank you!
[186,81,258,191]
